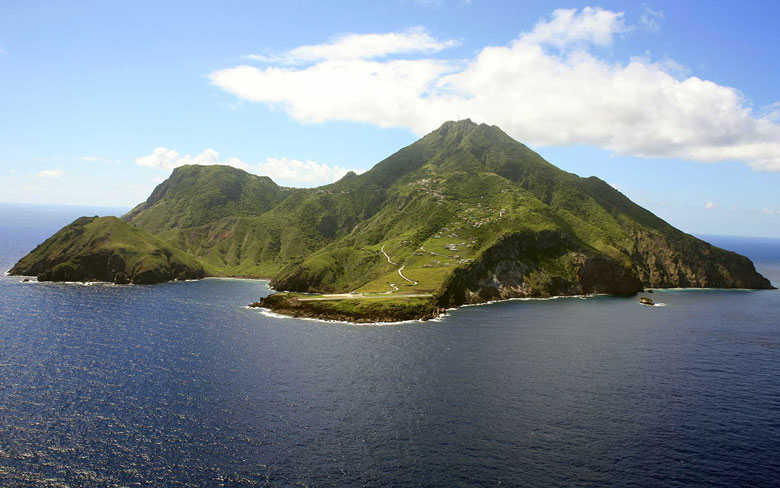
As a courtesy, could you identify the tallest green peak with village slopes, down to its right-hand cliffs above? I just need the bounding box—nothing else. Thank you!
[272,121,768,304]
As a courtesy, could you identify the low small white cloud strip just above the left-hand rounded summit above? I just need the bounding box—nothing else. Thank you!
[135,147,364,186]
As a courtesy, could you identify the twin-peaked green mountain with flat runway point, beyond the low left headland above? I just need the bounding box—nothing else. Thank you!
[9,120,771,320]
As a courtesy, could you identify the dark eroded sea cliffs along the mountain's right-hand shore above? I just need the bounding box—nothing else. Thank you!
[439,225,772,306]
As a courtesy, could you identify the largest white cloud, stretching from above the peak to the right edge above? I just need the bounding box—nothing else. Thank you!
[209,8,780,171]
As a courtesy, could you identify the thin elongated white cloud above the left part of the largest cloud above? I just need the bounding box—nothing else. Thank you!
[245,27,458,64]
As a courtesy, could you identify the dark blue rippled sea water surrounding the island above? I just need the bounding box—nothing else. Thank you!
[0,206,780,487]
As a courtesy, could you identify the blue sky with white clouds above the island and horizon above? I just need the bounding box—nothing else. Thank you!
[0,0,780,237]
